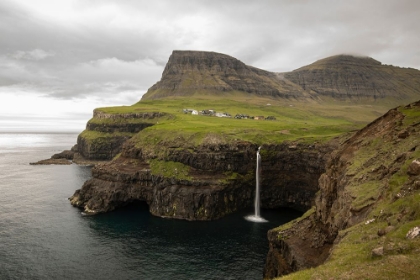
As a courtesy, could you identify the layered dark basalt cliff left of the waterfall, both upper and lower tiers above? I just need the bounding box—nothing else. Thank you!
[70,143,255,220]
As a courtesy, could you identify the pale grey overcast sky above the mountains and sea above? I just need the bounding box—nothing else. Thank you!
[0,0,420,132]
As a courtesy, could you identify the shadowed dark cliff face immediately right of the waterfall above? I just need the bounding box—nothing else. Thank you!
[261,143,337,211]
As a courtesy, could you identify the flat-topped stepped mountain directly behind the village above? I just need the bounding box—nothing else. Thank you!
[142,51,304,99]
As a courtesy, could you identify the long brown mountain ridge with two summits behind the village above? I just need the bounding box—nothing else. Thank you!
[142,51,420,103]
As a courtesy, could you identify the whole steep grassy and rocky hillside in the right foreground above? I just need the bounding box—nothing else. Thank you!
[265,102,420,279]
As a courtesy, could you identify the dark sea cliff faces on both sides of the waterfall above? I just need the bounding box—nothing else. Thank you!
[71,138,334,220]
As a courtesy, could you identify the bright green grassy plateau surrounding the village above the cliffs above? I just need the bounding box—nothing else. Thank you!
[91,92,396,147]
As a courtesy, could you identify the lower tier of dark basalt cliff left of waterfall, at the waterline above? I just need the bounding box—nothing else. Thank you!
[70,159,252,220]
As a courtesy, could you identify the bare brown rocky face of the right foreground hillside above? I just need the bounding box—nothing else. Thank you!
[264,102,420,278]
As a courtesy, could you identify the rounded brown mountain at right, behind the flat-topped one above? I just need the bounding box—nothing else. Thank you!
[284,55,420,101]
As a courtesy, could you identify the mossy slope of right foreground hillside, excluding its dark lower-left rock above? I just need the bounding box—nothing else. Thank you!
[275,102,420,279]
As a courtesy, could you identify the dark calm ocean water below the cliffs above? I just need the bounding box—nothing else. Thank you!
[0,133,300,280]
